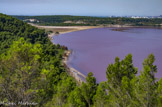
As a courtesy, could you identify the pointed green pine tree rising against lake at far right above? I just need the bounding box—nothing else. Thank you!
[135,54,157,107]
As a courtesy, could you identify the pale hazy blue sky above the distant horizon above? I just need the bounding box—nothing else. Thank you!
[0,0,162,16]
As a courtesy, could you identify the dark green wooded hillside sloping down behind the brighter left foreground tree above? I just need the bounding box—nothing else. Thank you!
[0,14,50,54]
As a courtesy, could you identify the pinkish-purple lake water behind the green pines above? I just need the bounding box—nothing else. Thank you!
[53,28,162,82]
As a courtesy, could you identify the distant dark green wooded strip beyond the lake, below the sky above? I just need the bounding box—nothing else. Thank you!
[14,15,162,26]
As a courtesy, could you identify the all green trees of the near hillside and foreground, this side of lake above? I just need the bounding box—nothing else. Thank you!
[0,14,162,107]
